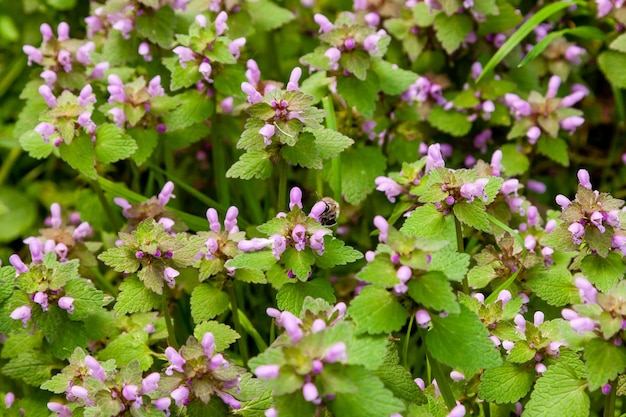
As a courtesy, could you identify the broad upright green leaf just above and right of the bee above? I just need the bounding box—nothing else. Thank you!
[326,146,385,204]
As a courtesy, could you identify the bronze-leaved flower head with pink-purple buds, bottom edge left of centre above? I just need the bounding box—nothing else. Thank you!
[161,332,245,410]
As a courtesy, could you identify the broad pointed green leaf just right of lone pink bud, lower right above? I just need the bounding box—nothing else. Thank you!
[426,304,502,377]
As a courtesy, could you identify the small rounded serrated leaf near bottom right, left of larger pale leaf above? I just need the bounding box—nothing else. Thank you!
[478,362,536,404]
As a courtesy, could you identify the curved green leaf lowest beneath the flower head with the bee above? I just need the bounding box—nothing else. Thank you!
[276,278,337,316]
